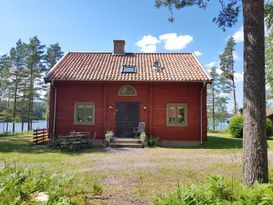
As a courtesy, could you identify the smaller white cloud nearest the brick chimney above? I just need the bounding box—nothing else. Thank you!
[136,35,160,53]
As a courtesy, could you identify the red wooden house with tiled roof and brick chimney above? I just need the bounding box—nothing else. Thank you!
[45,40,211,146]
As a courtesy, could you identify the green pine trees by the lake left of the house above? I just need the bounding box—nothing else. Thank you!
[0,36,63,132]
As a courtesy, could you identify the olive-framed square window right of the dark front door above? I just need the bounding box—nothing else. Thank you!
[166,103,187,127]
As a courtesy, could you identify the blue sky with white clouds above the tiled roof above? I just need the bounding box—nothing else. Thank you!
[0,0,243,108]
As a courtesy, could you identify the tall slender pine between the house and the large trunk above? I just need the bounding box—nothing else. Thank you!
[220,37,237,114]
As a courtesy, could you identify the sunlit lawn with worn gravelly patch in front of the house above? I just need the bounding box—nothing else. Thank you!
[0,133,273,204]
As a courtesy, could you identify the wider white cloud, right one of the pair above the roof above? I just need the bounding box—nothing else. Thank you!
[159,33,193,50]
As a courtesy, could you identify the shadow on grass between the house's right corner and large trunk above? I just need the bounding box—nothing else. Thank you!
[204,136,243,149]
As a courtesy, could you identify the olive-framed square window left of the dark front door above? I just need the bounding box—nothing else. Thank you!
[74,102,95,125]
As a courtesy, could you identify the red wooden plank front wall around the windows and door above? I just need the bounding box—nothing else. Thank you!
[49,81,207,141]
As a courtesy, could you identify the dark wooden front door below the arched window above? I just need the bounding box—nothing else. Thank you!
[116,102,139,138]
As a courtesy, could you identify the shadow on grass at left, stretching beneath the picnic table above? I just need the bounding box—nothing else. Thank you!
[0,136,106,155]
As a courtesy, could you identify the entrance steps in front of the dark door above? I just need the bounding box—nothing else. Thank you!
[109,138,144,148]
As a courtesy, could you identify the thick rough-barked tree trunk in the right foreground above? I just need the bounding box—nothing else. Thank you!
[242,0,268,185]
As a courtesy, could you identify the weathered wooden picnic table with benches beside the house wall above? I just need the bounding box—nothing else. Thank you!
[58,131,96,150]
